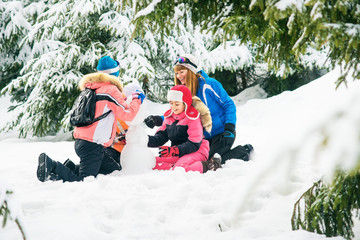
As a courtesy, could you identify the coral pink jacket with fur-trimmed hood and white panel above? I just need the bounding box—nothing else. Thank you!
[74,73,141,147]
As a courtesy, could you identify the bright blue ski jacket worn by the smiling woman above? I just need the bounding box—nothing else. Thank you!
[196,70,236,139]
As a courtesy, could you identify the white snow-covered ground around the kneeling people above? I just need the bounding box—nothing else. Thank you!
[0,70,360,240]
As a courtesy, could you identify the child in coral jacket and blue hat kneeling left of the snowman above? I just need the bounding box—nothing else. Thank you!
[36,56,145,182]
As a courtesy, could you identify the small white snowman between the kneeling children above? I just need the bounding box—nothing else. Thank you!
[120,83,156,174]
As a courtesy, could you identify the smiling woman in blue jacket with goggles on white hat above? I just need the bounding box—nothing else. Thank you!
[145,54,253,163]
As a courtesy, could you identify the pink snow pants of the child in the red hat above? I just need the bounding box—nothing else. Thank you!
[153,139,209,173]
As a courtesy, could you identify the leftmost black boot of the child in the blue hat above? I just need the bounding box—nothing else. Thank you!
[36,153,57,182]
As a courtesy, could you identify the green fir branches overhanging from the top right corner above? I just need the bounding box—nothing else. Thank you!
[134,0,360,85]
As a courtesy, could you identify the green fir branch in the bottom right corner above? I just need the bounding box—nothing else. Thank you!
[291,167,360,240]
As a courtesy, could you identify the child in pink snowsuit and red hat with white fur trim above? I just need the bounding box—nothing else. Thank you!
[148,85,221,173]
